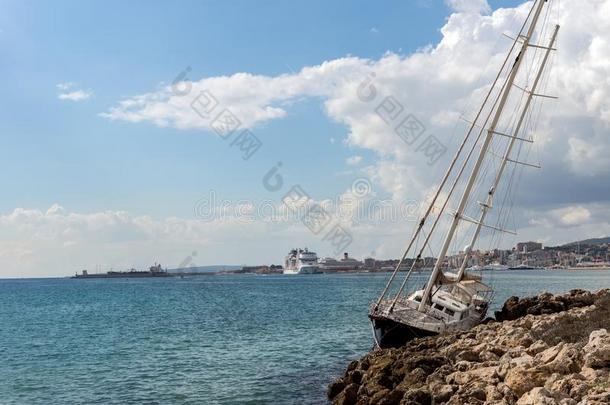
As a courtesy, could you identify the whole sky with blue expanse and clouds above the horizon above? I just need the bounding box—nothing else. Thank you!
[0,0,610,277]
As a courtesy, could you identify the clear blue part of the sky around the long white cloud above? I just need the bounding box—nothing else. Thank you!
[0,1,512,216]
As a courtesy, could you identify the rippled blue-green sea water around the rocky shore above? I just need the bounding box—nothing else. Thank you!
[0,271,610,404]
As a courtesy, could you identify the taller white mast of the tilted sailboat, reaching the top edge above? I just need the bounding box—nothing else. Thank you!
[418,0,546,312]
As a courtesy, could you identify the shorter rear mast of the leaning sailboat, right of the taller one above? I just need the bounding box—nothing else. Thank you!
[457,25,559,281]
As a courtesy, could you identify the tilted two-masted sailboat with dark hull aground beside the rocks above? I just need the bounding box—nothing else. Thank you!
[369,0,559,347]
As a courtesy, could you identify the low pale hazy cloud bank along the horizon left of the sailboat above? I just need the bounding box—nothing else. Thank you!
[0,197,417,278]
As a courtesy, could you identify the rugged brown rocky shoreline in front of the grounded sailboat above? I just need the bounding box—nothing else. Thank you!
[328,290,610,405]
